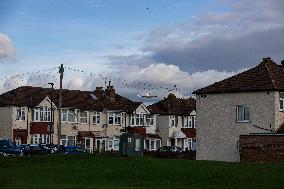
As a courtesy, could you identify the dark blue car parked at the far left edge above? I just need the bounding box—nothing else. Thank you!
[0,139,23,156]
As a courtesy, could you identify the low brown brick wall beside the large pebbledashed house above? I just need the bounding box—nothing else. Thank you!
[239,135,284,162]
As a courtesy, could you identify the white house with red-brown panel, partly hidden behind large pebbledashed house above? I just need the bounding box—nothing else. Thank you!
[148,93,196,150]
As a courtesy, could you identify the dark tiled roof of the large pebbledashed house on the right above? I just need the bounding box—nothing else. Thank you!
[193,57,284,94]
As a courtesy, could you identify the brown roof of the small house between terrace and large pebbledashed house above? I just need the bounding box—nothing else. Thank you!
[147,94,196,116]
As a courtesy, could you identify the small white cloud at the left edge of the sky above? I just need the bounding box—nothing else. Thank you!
[0,33,15,63]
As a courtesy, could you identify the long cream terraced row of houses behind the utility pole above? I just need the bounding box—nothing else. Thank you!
[0,86,160,151]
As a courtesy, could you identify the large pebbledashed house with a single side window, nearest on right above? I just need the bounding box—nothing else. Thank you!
[194,57,284,161]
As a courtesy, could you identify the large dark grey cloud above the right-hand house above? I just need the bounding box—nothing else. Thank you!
[142,0,284,73]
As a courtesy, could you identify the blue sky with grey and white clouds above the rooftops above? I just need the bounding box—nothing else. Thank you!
[0,0,284,101]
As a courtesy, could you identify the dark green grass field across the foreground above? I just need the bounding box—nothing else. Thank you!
[0,155,284,189]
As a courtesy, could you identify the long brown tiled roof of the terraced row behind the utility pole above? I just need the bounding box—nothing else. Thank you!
[0,86,142,112]
